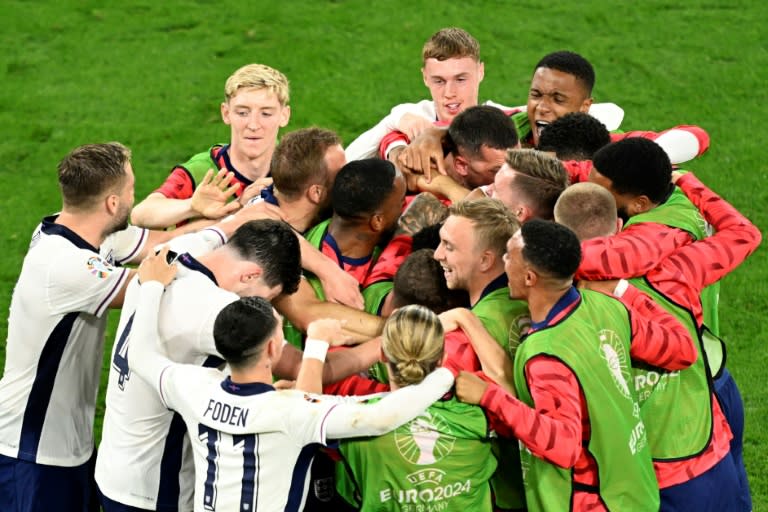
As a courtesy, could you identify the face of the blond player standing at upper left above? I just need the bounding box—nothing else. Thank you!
[221,88,291,177]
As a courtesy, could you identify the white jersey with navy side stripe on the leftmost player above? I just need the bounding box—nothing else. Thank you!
[0,216,148,467]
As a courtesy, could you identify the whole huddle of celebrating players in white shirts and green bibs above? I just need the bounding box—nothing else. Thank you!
[0,28,761,512]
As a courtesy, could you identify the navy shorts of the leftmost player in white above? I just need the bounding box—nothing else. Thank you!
[0,451,99,512]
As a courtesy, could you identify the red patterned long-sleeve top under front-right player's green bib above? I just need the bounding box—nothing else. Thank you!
[480,286,697,511]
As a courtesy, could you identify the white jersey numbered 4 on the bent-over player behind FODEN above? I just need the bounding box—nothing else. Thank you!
[96,254,239,510]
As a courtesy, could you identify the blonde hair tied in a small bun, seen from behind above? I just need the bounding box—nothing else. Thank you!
[381,305,445,386]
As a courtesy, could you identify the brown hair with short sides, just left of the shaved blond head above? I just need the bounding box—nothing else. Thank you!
[506,149,568,220]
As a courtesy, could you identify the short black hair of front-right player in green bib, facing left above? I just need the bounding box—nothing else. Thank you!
[520,219,581,280]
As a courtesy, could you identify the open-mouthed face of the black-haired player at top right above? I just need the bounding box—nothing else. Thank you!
[528,68,592,146]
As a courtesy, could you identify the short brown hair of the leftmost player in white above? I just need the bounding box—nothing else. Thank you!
[58,142,131,211]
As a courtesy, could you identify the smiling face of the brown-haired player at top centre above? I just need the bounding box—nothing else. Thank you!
[421,57,485,122]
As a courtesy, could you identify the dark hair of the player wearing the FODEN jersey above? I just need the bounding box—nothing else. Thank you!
[213,297,278,368]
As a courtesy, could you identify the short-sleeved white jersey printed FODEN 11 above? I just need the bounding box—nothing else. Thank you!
[159,365,334,512]
